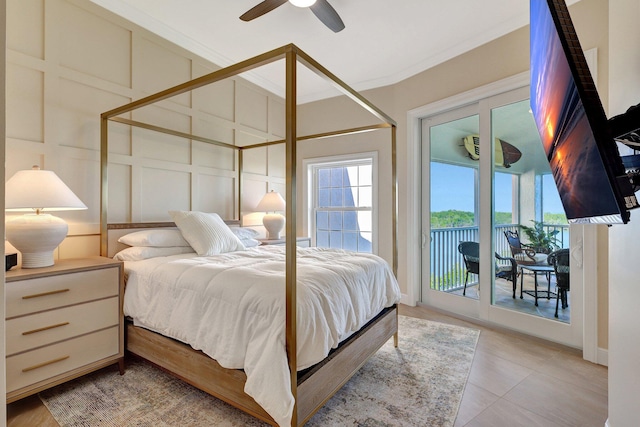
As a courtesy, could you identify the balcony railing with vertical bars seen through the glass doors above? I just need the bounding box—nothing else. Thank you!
[431,224,569,292]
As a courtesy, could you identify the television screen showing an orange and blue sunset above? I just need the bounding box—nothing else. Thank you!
[531,0,622,223]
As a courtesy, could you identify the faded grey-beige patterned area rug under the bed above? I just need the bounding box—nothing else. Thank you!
[40,316,480,427]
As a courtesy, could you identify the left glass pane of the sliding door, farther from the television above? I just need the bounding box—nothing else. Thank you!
[423,114,479,300]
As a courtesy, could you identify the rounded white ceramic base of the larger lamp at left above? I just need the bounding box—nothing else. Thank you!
[6,214,69,268]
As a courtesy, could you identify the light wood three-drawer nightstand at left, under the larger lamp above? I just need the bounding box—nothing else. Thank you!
[5,257,124,403]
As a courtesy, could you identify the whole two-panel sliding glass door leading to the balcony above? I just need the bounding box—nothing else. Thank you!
[421,84,582,345]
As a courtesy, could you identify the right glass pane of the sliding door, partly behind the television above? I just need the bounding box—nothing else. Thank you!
[491,100,571,323]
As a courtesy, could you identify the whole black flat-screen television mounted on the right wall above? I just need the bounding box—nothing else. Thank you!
[530,0,640,224]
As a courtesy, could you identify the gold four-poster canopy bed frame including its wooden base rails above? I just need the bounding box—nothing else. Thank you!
[100,44,398,426]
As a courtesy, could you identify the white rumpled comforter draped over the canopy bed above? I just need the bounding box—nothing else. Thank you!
[124,246,400,426]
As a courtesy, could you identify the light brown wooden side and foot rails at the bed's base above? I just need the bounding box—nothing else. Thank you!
[126,305,398,426]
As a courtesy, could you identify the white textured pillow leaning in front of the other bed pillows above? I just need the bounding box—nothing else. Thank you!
[169,211,245,256]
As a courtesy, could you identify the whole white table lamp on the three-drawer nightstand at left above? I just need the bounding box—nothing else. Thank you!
[5,166,87,268]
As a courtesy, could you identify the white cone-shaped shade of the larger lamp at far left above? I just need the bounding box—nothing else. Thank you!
[5,166,87,212]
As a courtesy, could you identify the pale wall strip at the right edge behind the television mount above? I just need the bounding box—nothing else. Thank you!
[607,0,640,427]
